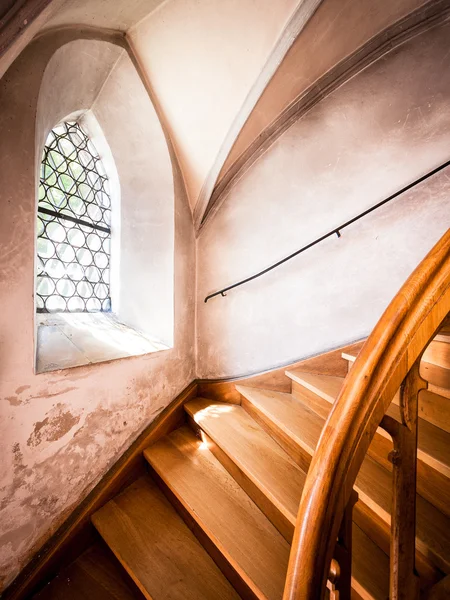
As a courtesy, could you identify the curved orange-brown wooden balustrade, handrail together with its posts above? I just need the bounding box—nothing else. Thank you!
[283,230,450,600]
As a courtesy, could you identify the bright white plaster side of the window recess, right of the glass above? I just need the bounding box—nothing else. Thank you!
[93,53,174,346]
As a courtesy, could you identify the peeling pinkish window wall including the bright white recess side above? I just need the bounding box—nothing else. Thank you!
[0,32,195,590]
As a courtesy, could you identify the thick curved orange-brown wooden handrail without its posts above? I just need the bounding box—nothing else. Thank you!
[284,229,450,600]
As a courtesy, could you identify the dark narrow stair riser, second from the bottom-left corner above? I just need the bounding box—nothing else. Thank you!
[149,465,260,600]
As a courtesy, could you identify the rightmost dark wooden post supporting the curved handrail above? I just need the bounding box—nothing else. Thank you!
[382,358,427,600]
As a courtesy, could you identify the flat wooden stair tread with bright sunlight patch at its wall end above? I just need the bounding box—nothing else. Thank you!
[185,398,306,524]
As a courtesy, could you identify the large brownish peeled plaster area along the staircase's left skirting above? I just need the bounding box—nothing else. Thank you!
[0,396,159,585]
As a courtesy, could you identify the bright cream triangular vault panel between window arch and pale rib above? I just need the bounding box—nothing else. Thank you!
[128,0,298,208]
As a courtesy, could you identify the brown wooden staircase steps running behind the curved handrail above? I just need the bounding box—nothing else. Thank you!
[34,326,450,600]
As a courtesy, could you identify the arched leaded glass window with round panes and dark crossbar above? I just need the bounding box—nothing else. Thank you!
[36,122,111,313]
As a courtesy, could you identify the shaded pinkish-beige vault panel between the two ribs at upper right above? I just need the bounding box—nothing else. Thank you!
[219,0,425,180]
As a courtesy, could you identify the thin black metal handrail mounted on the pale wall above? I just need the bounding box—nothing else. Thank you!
[205,160,450,302]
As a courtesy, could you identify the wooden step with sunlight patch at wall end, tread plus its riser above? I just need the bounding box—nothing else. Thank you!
[185,398,306,542]
